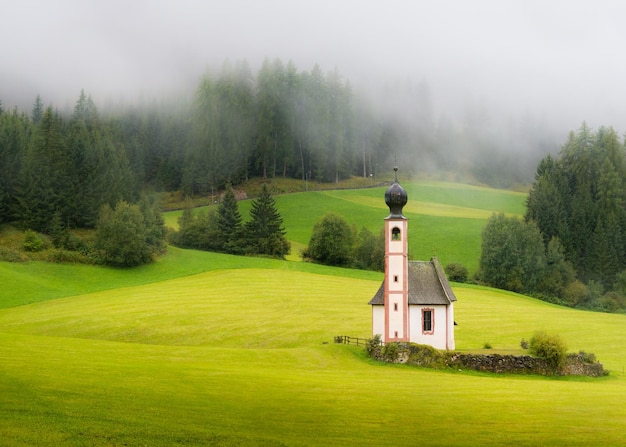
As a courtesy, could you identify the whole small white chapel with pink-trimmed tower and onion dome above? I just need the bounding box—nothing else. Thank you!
[368,167,456,350]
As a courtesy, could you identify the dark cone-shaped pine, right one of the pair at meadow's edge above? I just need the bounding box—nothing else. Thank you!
[245,184,291,258]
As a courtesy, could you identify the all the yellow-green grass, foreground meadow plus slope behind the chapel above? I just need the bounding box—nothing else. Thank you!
[0,180,626,446]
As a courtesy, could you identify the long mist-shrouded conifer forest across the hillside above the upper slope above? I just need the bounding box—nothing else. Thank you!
[0,59,549,231]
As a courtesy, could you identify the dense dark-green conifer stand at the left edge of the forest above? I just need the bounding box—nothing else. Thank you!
[0,93,135,233]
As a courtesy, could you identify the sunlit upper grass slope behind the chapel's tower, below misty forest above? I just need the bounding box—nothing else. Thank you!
[165,182,526,274]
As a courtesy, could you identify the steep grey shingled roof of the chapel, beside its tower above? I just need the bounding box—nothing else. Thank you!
[368,258,456,305]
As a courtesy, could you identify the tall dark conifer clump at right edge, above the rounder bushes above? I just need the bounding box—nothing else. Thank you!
[526,123,626,288]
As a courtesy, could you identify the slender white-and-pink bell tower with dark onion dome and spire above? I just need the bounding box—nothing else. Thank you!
[383,166,410,342]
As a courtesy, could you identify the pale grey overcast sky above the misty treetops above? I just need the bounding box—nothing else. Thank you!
[0,0,626,132]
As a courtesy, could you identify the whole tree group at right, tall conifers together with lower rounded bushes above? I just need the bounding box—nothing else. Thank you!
[480,124,626,310]
